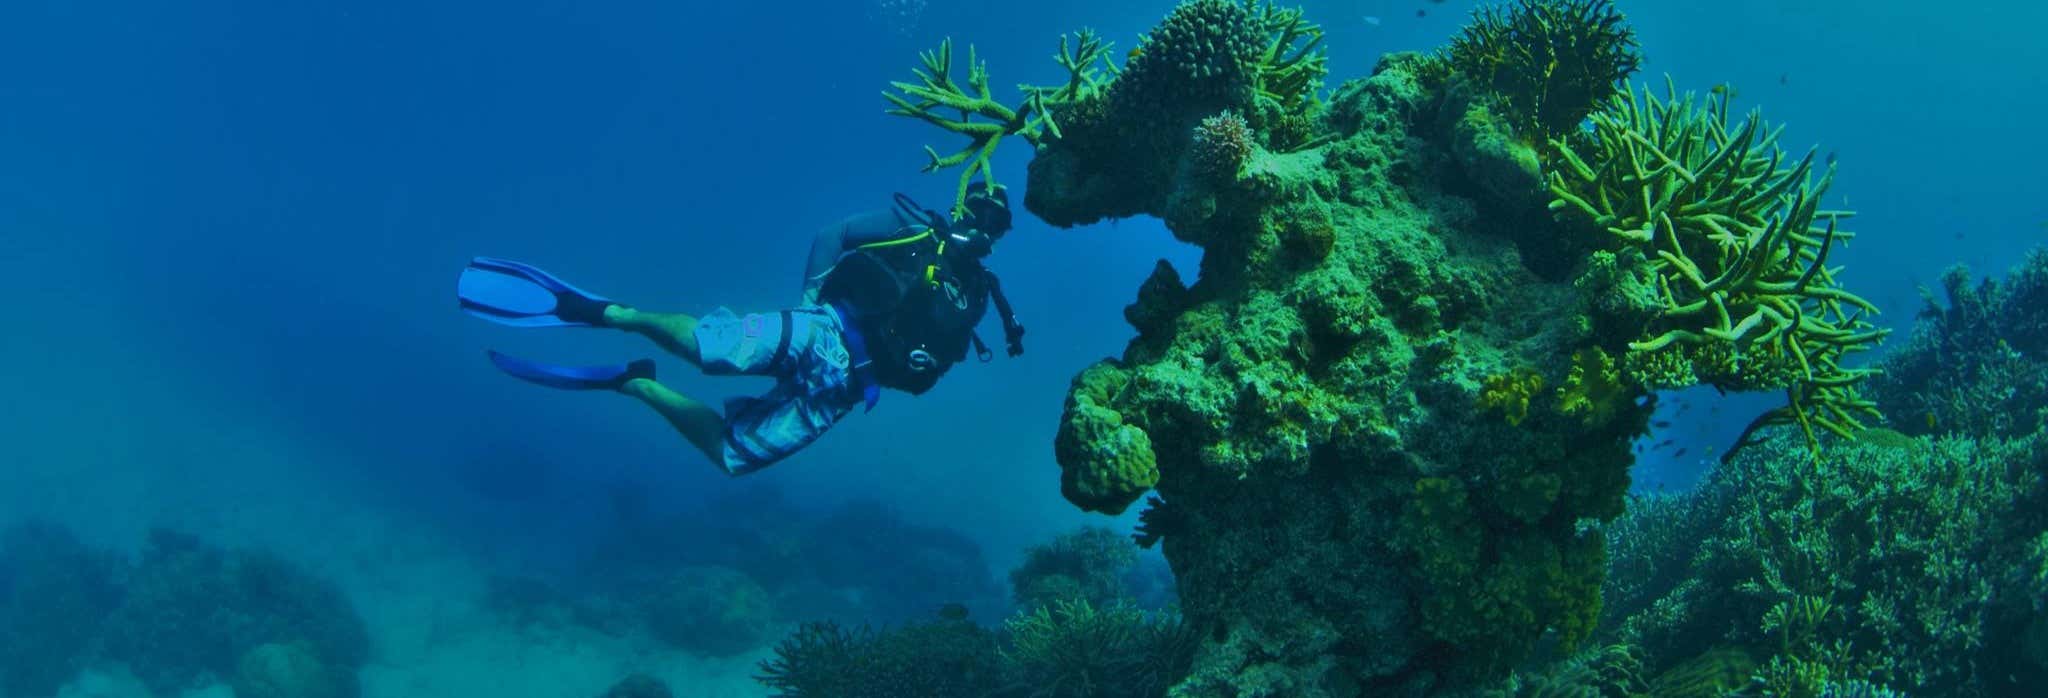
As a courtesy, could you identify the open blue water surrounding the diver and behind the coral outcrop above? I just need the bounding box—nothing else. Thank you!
[0,0,2048,694]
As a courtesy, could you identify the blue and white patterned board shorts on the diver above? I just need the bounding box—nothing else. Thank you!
[696,305,862,475]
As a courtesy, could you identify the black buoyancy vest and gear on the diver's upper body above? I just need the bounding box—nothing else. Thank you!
[819,194,1024,393]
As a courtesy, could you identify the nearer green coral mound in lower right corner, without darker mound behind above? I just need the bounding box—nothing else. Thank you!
[1608,430,2048,696]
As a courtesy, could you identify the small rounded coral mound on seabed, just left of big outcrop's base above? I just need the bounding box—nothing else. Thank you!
[1010,526,1139,610]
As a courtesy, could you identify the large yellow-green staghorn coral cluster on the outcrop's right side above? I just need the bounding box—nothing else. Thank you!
[1550,86,1886,446]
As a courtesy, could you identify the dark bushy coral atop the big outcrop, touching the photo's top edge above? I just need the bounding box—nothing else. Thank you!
[1438,0,1642,143]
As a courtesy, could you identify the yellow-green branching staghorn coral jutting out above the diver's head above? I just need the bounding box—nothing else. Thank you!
[883,29,1114,217]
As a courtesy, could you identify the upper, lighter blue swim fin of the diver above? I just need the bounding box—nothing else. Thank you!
[455,258,614,328]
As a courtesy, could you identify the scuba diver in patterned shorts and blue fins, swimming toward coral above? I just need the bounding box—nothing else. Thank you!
[457,182,1024,475]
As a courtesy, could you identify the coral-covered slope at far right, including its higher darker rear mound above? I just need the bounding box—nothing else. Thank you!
[1602,250,2048,696]
